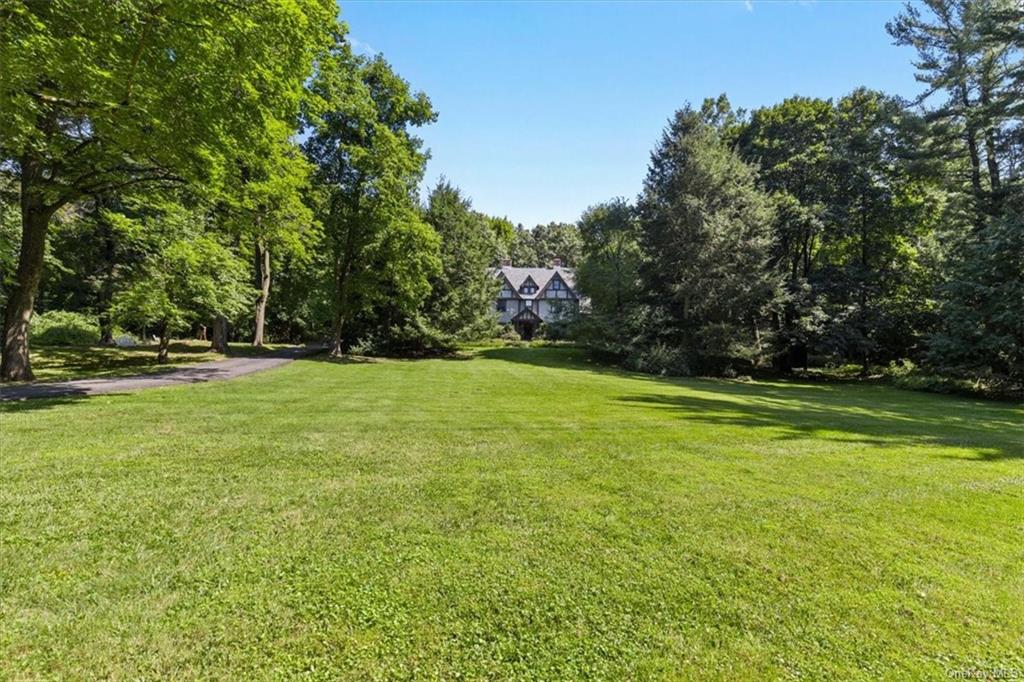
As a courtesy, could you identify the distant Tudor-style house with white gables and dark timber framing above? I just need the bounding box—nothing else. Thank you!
[495,258,580,340]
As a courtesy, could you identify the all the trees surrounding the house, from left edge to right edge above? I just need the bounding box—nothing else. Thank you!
[0,0,1024,393]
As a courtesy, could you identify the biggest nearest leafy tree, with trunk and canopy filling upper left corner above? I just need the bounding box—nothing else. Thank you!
[0,0,337,380]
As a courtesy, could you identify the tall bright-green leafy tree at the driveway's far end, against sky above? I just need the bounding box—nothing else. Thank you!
[304,35,440,355]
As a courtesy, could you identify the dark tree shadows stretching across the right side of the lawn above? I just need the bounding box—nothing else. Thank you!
[479,348,1024,461]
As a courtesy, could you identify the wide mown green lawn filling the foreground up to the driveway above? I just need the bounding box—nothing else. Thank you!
[0,348,1024,680]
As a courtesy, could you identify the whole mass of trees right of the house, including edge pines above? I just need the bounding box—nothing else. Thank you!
[579,0,1024,387]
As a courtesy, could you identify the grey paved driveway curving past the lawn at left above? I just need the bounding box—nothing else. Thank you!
[0,347,323,402]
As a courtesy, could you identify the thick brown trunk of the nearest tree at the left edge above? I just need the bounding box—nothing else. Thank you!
[0,157,54,381]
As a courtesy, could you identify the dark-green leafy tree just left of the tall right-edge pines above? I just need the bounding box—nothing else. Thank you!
[813,89,935,374]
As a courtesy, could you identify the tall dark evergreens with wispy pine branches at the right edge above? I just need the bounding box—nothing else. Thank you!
[887,0,1024,386]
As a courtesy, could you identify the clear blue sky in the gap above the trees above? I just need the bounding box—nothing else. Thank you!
[341,0,920,226]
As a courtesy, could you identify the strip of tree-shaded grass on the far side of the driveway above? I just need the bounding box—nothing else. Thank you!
[18,340,294,381]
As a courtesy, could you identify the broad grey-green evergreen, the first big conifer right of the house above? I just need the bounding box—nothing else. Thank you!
[638,106,780,369]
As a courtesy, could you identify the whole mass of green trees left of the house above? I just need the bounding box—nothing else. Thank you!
[0,0,514,380]
